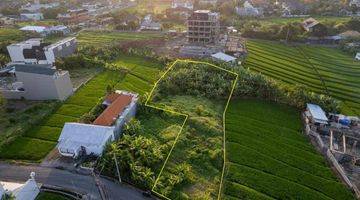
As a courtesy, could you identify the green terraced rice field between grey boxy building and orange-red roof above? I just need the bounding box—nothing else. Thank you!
[0,56,160,162]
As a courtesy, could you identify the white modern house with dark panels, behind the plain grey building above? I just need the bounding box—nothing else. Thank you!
[7,37,77,64]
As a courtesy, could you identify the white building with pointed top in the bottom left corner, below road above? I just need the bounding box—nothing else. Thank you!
[0,172,41,200]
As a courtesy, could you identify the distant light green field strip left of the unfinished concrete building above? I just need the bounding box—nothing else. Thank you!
[77,31,162,46]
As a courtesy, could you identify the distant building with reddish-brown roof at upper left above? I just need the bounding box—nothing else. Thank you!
[57,9,90,24]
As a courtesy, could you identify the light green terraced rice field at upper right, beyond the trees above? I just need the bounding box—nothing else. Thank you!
[245,40,360,115]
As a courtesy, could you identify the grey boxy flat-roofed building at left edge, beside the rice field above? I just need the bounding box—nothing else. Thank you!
[0,64,73,101]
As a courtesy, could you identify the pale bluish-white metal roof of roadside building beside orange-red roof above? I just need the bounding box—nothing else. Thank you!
[58,123,114,158]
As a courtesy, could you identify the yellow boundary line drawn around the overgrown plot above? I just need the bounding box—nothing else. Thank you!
[145,59,239,200]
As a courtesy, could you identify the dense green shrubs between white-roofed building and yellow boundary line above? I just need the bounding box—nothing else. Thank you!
[98,105,184,189]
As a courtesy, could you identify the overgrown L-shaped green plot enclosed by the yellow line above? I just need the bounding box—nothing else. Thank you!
[151,61,235,199]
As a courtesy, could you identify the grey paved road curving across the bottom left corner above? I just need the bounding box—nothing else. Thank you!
[0,163,150,200]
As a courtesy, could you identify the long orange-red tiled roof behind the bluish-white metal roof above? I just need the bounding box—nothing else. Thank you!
[93,94,132,126]
